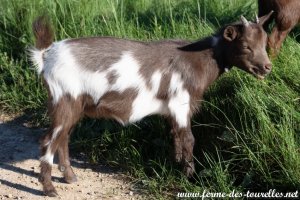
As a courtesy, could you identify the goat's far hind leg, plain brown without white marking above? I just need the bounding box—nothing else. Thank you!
[58,133,77,183]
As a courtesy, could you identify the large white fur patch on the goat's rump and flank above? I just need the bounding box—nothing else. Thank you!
[35,41,108,104]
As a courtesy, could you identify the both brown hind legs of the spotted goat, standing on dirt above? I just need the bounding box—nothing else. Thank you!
[39,97,81,196]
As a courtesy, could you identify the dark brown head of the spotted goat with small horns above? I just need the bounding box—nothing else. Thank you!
[222,12,272,79]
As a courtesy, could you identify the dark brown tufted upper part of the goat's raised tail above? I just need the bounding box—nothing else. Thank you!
[32,16,54,50]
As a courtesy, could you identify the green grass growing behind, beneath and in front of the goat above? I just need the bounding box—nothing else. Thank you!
[0,0,300,199]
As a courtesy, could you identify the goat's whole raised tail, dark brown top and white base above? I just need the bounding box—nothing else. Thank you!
[29,16,54,74]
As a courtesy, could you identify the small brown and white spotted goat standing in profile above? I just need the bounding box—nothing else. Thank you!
[31,14,271,196]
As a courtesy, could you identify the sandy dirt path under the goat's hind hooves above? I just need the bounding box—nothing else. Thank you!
[0,116,143,200]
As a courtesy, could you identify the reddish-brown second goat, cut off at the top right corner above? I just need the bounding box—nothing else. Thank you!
[258,0,300,57]
